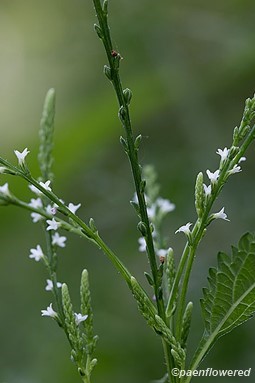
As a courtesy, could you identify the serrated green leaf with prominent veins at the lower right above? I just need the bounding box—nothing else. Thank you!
[187,233,255,376]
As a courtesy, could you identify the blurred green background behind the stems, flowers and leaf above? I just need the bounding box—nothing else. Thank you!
[0,0,255,383]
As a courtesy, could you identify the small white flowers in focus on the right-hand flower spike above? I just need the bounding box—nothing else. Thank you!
[175,148,246,237]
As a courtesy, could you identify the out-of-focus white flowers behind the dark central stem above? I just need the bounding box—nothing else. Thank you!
[133,193,175,258]
